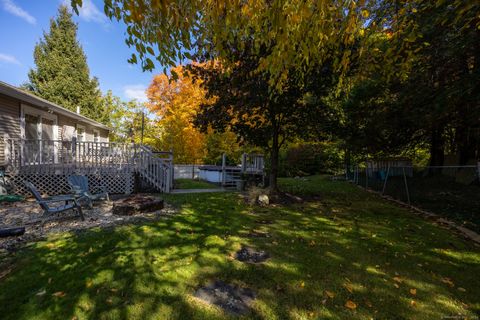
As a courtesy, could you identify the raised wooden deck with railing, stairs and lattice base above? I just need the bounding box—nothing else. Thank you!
[1,139,173,194]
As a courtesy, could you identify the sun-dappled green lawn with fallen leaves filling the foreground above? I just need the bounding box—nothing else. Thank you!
[0,177,480,320]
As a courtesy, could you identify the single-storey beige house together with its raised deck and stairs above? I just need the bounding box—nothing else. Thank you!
[0,81,173,194]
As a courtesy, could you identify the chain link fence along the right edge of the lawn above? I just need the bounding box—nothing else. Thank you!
[346,164,480,232]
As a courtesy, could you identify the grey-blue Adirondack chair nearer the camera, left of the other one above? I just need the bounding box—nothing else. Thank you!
[23,181,85,221]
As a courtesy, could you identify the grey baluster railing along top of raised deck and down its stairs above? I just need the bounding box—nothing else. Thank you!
[4,139,173,192]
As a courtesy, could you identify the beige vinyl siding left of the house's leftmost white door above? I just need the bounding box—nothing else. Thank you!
[0,94,20,163]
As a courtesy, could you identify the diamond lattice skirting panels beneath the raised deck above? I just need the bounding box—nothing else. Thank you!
[8,171,135,195]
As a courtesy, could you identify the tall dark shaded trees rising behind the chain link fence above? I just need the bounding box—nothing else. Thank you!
[338,1,480,166]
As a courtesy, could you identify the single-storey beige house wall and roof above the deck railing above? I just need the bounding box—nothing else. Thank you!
[0,81,109,163]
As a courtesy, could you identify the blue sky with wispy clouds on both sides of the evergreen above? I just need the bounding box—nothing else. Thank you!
[0,0,154,101]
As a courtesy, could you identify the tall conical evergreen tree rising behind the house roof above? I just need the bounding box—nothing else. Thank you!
[27,5,104,121]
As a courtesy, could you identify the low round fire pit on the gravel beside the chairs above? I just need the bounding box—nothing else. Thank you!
[112,195,163,216]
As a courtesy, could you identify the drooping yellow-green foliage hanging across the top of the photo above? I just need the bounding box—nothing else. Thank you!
[72,0,370,89]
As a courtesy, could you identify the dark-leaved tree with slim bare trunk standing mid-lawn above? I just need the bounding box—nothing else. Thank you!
[190,43,334,193]
